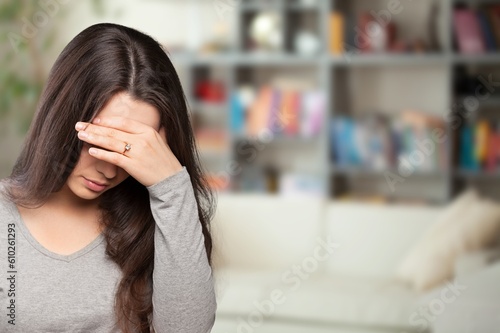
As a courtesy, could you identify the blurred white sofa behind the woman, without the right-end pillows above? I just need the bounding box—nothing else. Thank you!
[212,194,500,333]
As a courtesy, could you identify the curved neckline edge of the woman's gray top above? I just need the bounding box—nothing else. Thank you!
[9,197,104,262]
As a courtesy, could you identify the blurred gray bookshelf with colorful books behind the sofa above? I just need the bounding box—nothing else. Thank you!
[171,0,500,205]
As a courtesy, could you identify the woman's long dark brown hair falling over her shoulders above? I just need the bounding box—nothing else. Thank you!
[4,23,216,333]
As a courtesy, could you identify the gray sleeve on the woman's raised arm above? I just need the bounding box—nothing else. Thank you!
[148,167,216,333]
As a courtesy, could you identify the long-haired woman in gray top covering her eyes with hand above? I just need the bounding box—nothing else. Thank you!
[0,24,216,333]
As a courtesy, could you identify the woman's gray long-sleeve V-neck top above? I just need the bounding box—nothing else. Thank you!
[0,166,217,333]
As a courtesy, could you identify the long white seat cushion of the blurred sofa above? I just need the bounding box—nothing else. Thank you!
[213,270,424,332]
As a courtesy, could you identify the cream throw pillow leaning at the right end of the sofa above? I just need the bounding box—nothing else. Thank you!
[397,190,500,291]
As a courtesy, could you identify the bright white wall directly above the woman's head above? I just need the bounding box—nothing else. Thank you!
[55,0,236,64]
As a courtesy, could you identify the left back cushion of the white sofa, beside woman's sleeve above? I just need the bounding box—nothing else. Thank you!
[212,194,324,270]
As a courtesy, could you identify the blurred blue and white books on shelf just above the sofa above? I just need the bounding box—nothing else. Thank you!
[330,111,448,172]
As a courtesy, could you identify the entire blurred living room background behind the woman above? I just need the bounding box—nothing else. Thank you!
[0,0,500,333]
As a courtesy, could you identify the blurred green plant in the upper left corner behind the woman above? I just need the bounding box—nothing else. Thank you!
[0,0,104,135]
